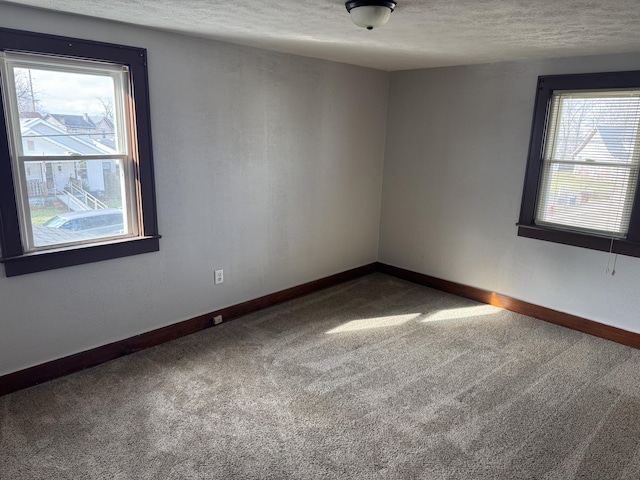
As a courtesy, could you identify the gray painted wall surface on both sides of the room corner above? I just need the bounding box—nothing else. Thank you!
[0,4,640,375]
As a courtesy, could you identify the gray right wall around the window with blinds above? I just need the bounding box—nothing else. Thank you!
[379,54,640,332]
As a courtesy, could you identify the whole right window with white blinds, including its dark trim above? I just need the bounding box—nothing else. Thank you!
[518,72,640,257]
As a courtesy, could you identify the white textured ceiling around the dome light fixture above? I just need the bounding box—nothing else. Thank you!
[3,0,640,70]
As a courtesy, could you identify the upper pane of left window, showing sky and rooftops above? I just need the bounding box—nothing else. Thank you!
[13,66,124,156]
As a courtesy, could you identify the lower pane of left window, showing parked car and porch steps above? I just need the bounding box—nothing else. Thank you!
[24,159,128,247]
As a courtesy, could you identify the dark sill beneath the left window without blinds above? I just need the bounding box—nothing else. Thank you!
[0,235,161,277]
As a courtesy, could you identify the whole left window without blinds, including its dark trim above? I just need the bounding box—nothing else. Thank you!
[0,29,160,276]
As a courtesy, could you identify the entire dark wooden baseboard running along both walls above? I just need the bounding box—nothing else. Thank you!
[0,262,640,396]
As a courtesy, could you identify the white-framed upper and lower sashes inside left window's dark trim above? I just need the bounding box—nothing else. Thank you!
[5,53,138,251]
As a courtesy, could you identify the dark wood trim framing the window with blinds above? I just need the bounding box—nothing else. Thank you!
[517,71,640,257]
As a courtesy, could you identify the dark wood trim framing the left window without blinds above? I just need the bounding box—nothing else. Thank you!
[0,28,160,277]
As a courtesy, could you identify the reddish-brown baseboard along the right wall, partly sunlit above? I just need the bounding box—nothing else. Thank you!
[377,263,640,348]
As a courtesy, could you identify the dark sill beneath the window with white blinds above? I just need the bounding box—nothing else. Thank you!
[516,223,640,258]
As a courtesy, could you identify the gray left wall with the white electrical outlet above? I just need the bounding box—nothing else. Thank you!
[0,4,389,375]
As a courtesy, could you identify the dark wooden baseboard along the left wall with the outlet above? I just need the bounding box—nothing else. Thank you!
[0,263,377,396]
